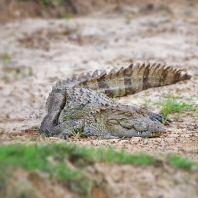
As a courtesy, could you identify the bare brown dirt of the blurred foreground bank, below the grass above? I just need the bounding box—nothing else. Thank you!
[1,163,198,198]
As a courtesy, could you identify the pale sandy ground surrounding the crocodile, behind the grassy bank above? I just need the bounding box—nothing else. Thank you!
[0,1,198,160]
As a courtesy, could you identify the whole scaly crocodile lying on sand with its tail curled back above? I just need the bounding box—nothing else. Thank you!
[40,63,191,139]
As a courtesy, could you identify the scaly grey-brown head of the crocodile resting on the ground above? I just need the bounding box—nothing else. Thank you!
[106,107,166,137]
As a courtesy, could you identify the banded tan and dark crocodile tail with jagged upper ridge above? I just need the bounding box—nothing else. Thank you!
[71,63,191,98]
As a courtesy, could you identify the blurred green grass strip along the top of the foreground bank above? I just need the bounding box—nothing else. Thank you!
[0,144,196,170]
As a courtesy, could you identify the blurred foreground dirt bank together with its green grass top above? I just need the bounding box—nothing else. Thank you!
[0,142,198,198]
